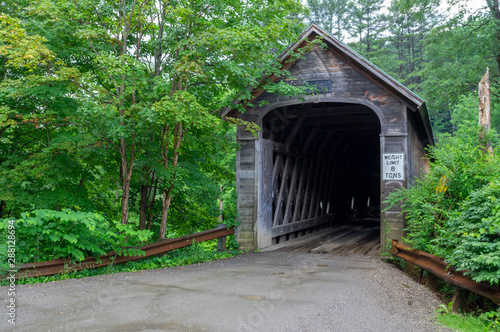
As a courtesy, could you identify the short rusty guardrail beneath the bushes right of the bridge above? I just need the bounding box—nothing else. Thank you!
[391,240,500,305]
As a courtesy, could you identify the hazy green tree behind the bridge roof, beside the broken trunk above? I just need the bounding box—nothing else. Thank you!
[418,12,499,132]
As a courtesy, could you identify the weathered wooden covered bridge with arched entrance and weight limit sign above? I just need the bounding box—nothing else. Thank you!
[224,24,434,249]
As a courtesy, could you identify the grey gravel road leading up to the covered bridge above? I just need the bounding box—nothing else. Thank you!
[0,252,447,332]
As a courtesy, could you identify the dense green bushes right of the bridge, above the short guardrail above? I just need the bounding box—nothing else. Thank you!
[387,130,500,284]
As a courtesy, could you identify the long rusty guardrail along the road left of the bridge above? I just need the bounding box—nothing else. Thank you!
[8,226,234,279]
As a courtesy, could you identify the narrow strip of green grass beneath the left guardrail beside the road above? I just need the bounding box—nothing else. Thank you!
[0,243,239,286]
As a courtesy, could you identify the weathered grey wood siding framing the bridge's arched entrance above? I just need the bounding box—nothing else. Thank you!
[237,41,423,249]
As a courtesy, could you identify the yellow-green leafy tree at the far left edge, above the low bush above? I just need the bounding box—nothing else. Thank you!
[0,14,91,216]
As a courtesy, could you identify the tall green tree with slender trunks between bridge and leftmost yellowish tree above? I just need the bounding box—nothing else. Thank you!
[2,0,312,241]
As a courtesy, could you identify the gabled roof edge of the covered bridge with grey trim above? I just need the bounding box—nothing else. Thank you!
[222,24,434,144]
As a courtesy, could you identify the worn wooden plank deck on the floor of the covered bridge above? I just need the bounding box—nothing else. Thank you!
[261,219,380,256]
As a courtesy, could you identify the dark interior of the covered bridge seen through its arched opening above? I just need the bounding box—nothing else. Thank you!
[262,103,381,248]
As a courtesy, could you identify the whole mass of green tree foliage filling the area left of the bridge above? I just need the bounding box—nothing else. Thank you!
[0,0,303,243]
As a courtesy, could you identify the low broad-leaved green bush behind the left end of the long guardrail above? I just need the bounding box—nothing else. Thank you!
[0,209,152,270]
